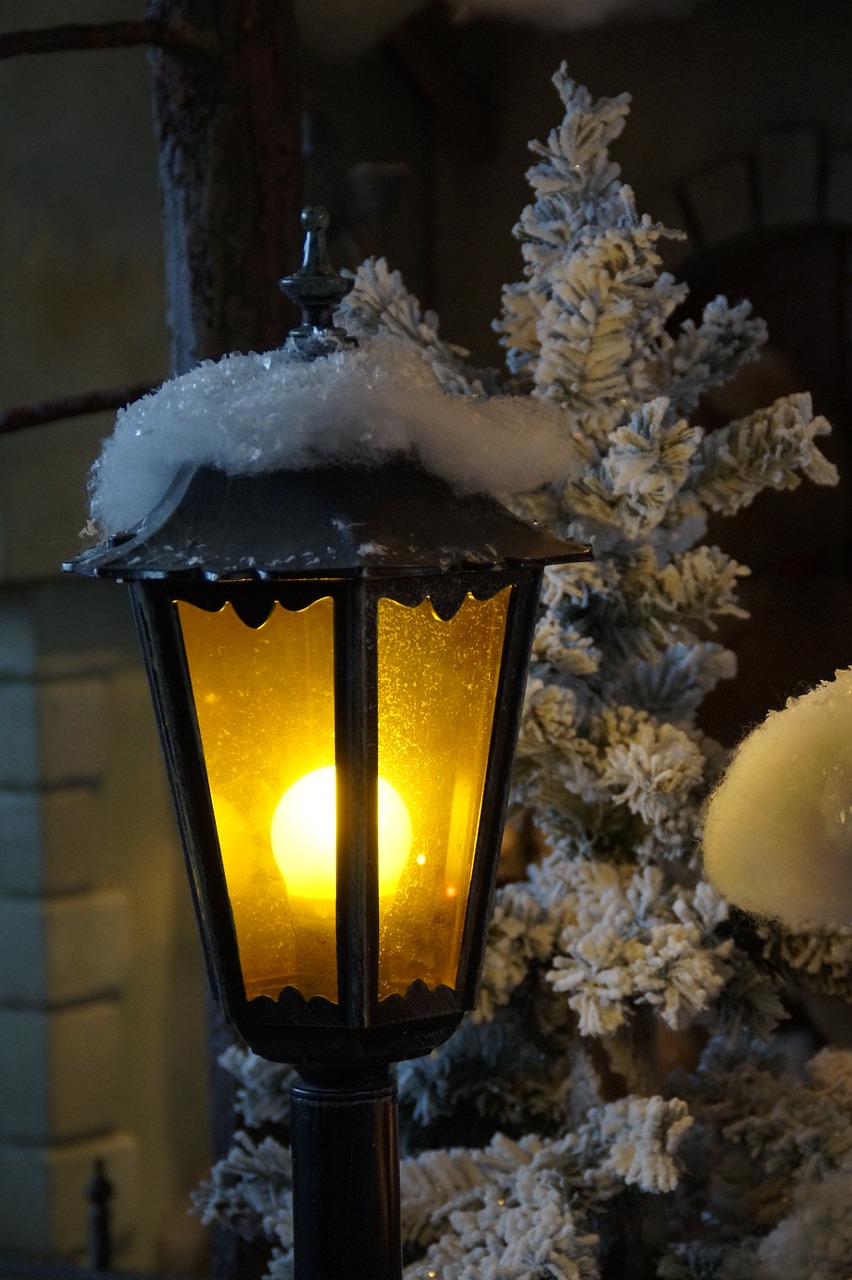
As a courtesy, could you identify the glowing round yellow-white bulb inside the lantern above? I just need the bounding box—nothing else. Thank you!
[270,764,412,901]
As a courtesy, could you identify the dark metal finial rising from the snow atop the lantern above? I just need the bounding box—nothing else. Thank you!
[279,205,356,360]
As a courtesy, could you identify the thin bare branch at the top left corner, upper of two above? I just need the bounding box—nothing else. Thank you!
[0,22,219,58]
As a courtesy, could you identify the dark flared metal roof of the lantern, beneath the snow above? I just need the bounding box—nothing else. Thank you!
[64,457,591,581]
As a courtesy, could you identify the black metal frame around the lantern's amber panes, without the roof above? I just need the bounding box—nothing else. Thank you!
[132,570,539,1066]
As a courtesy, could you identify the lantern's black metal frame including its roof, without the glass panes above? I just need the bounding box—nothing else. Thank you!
[73,460,587,1069]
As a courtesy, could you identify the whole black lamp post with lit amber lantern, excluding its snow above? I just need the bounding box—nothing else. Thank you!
[68,209,588,1280]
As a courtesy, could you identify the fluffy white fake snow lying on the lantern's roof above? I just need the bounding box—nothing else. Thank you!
[91,337,581,535]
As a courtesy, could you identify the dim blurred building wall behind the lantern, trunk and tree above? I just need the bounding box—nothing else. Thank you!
[0,0,852,1271]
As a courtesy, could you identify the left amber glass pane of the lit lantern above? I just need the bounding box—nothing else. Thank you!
[177,596,338,1001]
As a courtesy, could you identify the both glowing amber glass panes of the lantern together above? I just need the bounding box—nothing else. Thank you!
[177,588,512,1002]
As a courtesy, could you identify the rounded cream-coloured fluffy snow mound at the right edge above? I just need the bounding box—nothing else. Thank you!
[704,669,852,928]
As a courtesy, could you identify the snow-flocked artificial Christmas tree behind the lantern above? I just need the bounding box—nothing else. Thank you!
[190,69,852,1280]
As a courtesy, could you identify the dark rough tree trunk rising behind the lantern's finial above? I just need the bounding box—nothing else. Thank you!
[146,0,301,374]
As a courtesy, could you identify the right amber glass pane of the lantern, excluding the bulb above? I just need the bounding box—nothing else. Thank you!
[379,588,510,998]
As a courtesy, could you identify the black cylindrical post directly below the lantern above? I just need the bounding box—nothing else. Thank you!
[290,1068,402,1280]
